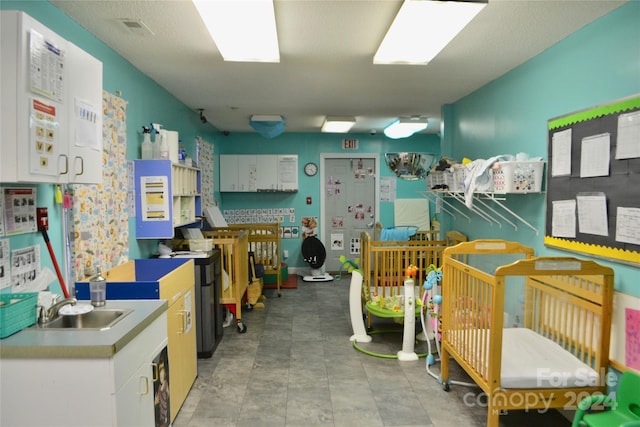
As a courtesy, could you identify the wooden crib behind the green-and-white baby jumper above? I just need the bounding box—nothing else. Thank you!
[360,231,466,327]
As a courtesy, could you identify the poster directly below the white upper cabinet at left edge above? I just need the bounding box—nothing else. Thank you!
[3,187,38,236]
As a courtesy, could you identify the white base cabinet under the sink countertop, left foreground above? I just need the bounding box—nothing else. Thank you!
[2,312,167,427]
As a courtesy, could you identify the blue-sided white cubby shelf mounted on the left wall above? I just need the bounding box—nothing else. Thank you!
[134,160,202,239]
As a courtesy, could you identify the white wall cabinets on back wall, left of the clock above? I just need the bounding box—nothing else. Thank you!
[220,154,298,192]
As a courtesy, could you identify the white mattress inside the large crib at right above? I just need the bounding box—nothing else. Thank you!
[451,328,599,389]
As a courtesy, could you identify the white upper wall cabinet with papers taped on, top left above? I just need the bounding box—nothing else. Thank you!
[0,11,102,184]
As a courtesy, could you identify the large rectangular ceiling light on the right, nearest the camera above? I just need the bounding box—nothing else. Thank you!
[373,0,486,64]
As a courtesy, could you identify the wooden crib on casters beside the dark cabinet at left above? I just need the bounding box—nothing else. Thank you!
[202,230,249,333]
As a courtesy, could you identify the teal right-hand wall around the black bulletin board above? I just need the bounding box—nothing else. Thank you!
[442,1,640,296]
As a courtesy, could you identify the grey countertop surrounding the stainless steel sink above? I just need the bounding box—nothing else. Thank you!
[0,300,168,359]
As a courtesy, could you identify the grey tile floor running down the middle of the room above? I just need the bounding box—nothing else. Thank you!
[173,276,571,427]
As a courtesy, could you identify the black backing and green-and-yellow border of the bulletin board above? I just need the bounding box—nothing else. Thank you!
[544,95,640,265]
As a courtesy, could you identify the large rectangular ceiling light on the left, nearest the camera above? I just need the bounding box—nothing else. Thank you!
[192,0,280,62]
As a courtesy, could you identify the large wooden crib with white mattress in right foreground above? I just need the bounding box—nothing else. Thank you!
[441,240,613,427]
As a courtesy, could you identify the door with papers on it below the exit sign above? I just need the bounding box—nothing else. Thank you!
[320,154,379,272]
